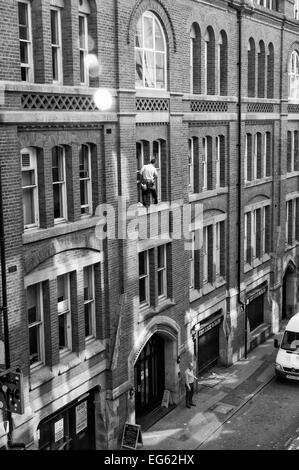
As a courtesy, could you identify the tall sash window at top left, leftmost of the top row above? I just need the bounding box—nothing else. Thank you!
[18,2,33,82]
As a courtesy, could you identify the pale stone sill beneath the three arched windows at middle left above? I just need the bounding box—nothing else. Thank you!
[23,217,101,245]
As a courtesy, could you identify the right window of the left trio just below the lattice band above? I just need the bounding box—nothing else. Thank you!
[79,144,92,215]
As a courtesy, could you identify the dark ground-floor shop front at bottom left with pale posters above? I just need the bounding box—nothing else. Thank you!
[38,391,95,450]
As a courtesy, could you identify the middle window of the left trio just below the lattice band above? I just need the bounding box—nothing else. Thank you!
[52,147,67,222]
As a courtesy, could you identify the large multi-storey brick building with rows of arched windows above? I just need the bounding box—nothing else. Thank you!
[0,0,299,449]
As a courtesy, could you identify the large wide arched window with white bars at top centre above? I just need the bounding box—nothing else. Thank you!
[135,11,167,90]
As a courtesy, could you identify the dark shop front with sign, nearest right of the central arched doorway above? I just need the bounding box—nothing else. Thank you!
[192,311,223,373]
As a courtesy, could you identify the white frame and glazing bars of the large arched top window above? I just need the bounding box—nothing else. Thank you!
[135,11,167,90]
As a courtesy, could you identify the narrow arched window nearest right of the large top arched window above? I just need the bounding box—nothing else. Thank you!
[190,23,201,93]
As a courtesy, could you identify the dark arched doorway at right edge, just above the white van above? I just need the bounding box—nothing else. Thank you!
[281,263,297,320]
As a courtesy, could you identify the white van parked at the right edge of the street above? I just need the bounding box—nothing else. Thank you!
[274,313,299,380]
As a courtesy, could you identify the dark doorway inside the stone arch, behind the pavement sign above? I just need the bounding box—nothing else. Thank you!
[134,334,165,422]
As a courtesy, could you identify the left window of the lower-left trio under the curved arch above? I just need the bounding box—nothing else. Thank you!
[27,284,44,366]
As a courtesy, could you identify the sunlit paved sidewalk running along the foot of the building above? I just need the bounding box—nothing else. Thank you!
[138,328,284,450]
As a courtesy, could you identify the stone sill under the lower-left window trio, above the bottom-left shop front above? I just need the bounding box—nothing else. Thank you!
[30,339,106,391]
